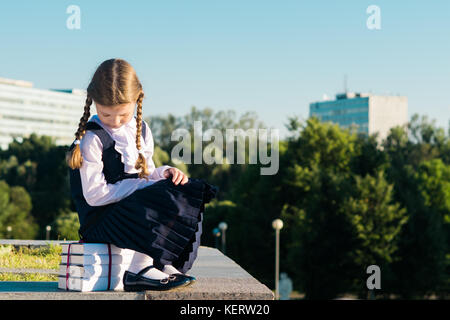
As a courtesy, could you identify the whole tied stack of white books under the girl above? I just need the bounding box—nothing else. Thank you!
[58,242,152,291]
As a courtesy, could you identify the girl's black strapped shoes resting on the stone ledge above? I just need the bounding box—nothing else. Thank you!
[123,266,190,292]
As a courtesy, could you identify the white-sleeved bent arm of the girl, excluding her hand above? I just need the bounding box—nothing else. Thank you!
[80,131,154,206]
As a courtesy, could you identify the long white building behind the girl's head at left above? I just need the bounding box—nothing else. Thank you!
[0,78,86,149]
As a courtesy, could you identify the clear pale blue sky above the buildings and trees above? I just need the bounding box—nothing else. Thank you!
[0,0,450,139]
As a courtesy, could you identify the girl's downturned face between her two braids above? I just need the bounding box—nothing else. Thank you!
[95,102,136,129]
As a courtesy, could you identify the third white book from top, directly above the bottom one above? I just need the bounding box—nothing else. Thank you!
[58,264,147,279]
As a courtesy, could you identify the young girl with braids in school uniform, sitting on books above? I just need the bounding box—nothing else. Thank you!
[67,59,218,291]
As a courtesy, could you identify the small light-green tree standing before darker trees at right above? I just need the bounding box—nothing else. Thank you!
[341,170,408,298]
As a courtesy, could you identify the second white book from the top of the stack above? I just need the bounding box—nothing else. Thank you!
[61,253,153,266]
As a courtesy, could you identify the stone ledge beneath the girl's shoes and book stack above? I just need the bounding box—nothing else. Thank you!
[0,246,274,300]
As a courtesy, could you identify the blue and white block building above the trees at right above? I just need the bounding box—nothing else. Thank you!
[309,92,408,142]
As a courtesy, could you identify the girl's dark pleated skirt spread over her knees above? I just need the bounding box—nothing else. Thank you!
[83,178,218,273]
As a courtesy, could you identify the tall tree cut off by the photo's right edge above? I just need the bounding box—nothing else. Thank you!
[383,115,449,298]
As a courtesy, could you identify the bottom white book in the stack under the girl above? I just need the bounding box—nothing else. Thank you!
[58,276,123,292]
